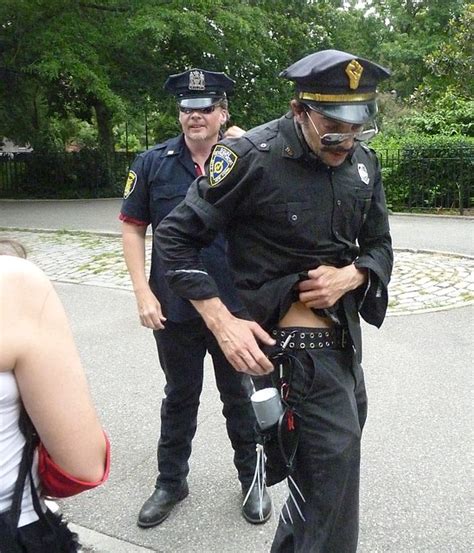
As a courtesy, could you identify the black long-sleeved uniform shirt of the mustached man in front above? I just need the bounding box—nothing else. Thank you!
[155,113,393,354]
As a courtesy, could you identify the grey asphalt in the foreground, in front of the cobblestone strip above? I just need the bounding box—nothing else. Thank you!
[57,285,474,553]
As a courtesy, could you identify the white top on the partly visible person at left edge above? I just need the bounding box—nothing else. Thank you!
[0,371,43,527]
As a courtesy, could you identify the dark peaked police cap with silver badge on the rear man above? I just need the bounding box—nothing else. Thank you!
[165,69,235,109]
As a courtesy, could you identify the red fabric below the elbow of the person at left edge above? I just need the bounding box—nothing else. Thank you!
[38,432,110,497]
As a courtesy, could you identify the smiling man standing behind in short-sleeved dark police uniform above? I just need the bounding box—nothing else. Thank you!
[120,69,271,527]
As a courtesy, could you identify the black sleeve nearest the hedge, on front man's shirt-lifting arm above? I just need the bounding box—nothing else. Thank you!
[354,156,393,327]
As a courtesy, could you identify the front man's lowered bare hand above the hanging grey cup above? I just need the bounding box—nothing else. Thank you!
[191,298,275,376]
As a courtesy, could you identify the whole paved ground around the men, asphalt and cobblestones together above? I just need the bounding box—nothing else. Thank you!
[0,200,474,553]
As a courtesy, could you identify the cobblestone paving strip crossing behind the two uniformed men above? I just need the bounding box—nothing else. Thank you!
[2,230,474,315]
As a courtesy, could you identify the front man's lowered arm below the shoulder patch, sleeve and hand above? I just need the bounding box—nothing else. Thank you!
[153,178,275,375]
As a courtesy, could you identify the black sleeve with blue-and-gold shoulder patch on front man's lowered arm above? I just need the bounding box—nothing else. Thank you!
[154,139,254,300]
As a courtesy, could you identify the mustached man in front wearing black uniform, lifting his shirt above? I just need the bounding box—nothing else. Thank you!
[155,50,393,553]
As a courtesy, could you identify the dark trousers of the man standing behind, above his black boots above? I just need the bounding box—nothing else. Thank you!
[153,319,256,490]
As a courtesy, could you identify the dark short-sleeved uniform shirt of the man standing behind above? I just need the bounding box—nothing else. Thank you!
[121,135,242,322]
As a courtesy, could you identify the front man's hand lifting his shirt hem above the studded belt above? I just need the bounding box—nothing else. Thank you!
[298,265,367,309]
